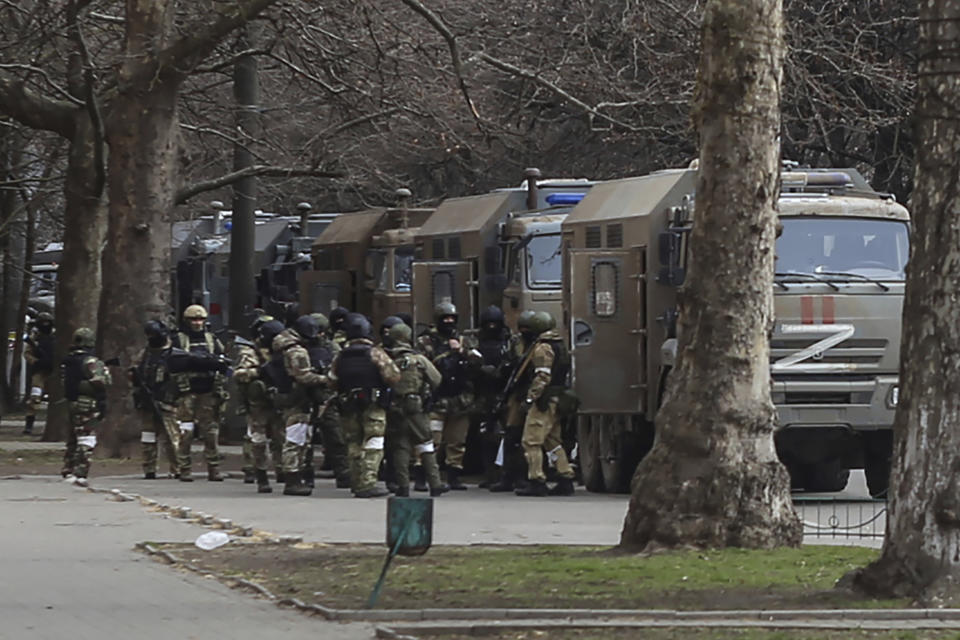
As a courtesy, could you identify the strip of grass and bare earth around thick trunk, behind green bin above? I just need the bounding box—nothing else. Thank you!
[159,544,908,610]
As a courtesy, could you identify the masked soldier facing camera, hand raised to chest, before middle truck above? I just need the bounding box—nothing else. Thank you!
[414,302,481,491]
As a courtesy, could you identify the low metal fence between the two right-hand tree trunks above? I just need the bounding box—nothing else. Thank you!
[793,497,887,538]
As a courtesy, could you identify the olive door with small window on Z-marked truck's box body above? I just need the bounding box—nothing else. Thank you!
[568,247,646,414]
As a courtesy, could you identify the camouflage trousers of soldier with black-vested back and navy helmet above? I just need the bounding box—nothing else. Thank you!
[340,402,387,493]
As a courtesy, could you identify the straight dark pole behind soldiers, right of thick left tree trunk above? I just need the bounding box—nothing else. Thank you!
[228,22,261,331]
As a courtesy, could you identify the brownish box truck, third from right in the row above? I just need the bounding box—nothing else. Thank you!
[299,189,433,326]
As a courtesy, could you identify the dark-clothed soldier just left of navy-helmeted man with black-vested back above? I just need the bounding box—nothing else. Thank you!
[307,313,350,489]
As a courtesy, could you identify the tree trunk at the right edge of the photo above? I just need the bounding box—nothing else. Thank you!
[843,0,960,606]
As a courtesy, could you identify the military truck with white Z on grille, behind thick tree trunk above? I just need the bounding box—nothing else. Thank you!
[562,164,909,496]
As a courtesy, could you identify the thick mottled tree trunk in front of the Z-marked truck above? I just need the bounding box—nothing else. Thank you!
[620,0,802,550]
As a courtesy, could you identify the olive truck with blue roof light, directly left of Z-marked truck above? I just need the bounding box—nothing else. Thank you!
[413,169,593,334]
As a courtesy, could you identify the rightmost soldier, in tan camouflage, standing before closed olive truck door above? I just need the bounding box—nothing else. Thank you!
[516,311,574,496]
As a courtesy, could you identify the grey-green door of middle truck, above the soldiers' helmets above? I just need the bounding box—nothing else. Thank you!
[413,261,477,335]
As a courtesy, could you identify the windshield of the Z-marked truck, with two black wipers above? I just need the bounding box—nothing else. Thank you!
[776,216,910,280]
